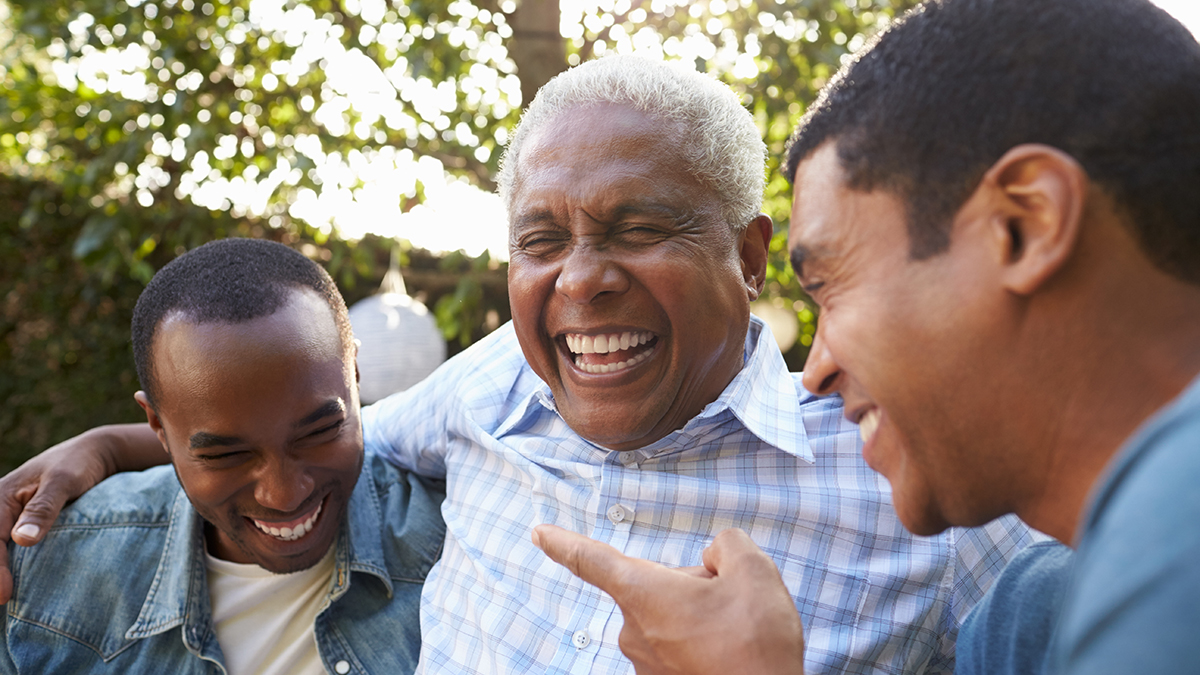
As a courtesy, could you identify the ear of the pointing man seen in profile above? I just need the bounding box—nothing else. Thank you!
[980,144,1088,295]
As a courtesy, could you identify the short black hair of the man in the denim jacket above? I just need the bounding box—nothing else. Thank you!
[132,239,354,406]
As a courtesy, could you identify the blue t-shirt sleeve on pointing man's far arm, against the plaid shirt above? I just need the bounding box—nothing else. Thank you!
[954,540,1073,675]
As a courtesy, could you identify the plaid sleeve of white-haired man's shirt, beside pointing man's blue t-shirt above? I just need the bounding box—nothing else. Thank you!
[930,515,1049,673]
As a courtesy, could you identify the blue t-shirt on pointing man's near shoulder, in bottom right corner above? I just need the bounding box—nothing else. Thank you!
[1050,377,1200,675]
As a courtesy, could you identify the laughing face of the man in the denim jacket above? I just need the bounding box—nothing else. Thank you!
[138,289,362,573]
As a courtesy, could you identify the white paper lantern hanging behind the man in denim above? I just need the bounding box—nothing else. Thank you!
[350,251,446,404]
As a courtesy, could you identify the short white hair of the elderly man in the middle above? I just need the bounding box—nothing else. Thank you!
[498,55,767,232]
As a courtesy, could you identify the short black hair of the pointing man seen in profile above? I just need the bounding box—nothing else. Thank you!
[787,0,1200,283]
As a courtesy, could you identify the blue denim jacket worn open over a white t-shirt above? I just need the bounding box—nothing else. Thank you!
[0,458,445,675]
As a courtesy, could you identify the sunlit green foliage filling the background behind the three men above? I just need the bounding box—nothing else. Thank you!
[0,0,914,461]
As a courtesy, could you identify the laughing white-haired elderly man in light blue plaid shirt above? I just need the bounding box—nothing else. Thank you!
[0,56,1031,674]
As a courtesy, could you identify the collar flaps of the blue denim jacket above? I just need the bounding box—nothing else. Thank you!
[126,454,392,640]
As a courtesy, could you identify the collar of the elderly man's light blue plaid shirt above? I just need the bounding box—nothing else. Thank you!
[496,315,815,462]
